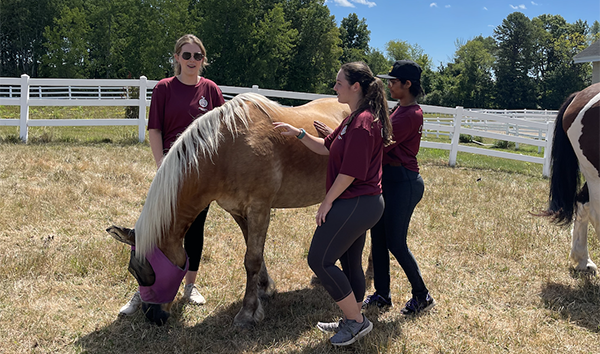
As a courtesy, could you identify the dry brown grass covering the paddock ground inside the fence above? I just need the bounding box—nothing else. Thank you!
[0,143,600,353]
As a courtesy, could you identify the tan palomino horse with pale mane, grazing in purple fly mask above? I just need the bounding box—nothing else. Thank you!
[107,93,350,326]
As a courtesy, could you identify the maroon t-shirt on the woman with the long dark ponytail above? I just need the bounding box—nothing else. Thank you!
[325,111,383,199]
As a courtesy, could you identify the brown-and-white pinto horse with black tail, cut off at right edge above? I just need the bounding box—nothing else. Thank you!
[543,83,600,273]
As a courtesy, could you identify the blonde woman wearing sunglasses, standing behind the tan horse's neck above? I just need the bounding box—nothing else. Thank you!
[120,34,225,315]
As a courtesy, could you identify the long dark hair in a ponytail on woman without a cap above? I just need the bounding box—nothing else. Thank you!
[341,61,394,146]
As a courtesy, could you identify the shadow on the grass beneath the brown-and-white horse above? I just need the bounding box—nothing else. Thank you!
[541,278,600,333]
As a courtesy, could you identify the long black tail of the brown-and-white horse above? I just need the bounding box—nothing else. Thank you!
[542,92,581,225]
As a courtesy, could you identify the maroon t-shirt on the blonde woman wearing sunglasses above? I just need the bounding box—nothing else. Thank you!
[148,76,225,152]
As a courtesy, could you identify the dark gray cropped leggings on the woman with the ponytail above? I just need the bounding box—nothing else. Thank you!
[308,195,384,302]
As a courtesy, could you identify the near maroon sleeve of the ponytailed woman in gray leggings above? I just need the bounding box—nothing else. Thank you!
[339,127,374,181]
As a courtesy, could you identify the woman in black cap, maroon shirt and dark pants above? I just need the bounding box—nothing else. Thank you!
[363,60,435,315]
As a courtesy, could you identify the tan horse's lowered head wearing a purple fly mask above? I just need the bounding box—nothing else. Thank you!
[106,226,182,326]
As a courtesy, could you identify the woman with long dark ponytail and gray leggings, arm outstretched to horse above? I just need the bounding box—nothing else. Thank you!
[274,62,391,345]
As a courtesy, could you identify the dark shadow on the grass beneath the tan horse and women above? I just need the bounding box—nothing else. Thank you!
[74,286,401,354]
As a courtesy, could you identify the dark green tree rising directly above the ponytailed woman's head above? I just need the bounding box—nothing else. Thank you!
[340,13,371,63]
